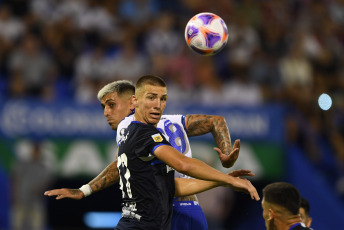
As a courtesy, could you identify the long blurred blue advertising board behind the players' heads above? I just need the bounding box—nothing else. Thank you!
[0,101,283,143]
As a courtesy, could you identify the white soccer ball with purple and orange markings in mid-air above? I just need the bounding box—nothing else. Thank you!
[185,12,228,56]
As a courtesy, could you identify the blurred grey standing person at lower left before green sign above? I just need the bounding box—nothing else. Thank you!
[11,143,52,230]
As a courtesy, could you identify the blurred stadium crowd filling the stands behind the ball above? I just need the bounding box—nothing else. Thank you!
[0,0,344,200]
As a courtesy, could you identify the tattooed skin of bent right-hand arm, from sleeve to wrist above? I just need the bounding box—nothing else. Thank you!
[185,115,232,155]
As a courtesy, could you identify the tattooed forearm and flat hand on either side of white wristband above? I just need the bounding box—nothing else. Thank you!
[44,160,119,200]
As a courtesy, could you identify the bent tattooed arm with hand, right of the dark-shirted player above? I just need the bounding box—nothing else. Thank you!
[185,115,240,168]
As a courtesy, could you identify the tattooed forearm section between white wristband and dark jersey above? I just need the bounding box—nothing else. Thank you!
[88,161,119,192]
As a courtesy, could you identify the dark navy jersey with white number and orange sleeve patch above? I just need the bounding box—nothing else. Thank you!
[117,121,175,230]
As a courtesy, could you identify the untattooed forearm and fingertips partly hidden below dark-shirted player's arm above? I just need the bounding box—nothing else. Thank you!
[174,169,254,197]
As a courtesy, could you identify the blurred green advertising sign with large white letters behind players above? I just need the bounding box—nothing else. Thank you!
[0,139,285,180]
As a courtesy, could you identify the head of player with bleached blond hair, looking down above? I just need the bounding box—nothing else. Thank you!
[97,80,135,130]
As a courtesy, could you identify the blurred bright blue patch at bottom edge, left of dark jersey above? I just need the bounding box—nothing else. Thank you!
[84,212,122,229]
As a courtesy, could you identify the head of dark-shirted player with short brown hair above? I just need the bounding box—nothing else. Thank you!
[133,75,167,125]
